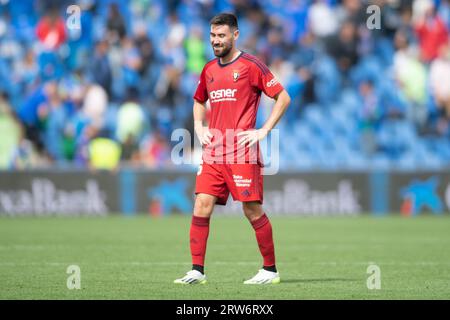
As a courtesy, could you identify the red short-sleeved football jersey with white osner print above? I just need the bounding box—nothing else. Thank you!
[194,52,283,163]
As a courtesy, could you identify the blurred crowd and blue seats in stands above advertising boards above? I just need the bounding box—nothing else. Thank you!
[0,0,450,169]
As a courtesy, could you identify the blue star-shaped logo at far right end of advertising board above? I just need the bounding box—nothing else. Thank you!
[400,176,450,216]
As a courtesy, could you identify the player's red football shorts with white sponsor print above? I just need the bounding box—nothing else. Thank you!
[195,163,264,205]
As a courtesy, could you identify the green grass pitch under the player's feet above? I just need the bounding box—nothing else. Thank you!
[0,216,450,299]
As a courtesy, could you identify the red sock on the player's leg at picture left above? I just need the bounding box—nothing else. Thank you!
[190,216,209,266]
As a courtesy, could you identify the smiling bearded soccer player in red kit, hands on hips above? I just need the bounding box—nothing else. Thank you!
[174,13,290,284]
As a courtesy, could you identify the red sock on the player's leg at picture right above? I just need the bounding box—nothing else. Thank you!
[251,213,275,267]
